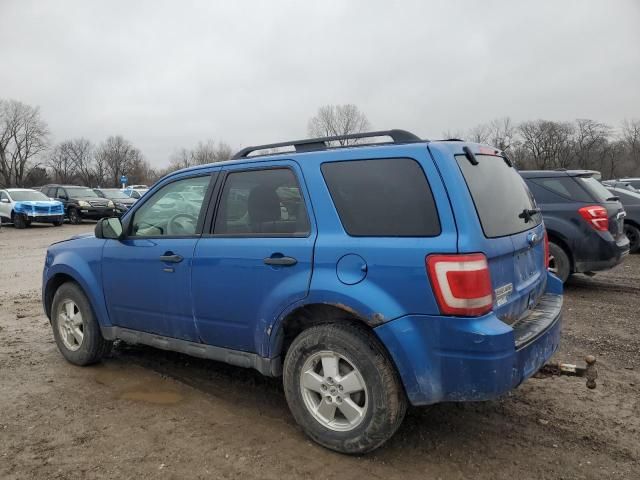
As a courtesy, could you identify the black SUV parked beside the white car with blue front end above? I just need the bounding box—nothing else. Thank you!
[40,185,116,224]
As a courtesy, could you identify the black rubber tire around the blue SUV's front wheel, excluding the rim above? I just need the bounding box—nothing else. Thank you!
[51,282,113,366]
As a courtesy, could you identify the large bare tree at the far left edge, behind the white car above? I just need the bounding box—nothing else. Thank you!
[0,100,49,186]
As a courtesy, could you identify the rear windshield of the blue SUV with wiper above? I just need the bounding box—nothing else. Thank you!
[456,155,542,238]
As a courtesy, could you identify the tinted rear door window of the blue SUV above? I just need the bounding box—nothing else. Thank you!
[214,168,309,236]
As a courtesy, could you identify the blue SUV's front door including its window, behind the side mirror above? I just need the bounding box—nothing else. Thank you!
[102,171,217,341]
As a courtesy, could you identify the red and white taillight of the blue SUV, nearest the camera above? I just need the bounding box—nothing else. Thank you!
[425,253,493,317]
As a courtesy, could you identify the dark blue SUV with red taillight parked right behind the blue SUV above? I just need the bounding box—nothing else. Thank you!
[520,170,629,282]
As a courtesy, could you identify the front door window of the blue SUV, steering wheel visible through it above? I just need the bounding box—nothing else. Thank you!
[130,175,211,237]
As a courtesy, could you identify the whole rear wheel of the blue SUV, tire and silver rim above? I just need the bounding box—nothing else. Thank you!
[283,324,407,454]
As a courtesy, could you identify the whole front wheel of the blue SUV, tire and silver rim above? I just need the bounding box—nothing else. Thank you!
[51,282,113,366]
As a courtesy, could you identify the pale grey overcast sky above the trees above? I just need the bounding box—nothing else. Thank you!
[0,0,640,166]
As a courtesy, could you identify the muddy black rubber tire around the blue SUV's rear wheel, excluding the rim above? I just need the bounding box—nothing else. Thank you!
[283,323,407,454]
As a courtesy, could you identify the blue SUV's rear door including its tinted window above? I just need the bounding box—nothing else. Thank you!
[192,162,316,355]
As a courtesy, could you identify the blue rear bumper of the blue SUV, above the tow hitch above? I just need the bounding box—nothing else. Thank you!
[375,277,562,405]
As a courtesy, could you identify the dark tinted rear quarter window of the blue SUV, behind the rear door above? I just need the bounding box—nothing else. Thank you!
[322,158,440,237]
